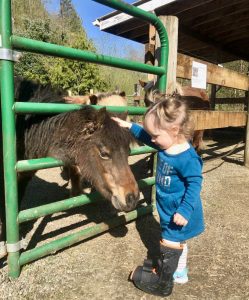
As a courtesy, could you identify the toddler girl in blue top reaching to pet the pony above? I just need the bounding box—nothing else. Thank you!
[113,95,204,296]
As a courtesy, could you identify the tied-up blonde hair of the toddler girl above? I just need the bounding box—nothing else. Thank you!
[144,94,194,139]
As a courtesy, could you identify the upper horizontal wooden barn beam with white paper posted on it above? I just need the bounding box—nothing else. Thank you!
[176,53,249,91]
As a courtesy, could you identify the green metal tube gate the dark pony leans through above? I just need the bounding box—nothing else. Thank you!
[0,0,168,278]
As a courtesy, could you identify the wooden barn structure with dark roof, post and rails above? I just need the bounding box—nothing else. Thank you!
[93,0,249,167]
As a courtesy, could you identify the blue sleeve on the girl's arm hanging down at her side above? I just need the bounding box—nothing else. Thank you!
[176,157,202,220]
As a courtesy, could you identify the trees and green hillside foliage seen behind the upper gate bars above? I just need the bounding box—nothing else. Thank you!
[12,0,146,95]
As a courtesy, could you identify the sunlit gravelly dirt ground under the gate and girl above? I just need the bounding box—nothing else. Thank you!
[0,132,249,300]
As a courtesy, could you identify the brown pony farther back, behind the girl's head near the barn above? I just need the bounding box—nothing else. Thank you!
[139,80,210,152]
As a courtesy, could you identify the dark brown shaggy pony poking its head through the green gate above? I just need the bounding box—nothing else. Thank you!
[0,77,139,255]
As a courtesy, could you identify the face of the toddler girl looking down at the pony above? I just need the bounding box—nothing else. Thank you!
[144,115,179,150]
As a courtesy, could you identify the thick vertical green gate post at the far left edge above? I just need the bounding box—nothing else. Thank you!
[0,0,20,277]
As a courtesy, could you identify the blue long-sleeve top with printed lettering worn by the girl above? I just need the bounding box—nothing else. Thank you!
[130,123,204,242]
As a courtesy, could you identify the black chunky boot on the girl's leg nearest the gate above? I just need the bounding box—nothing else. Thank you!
[130,244,182,297]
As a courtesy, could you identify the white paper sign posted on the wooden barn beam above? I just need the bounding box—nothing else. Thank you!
[191,61,207,89]
